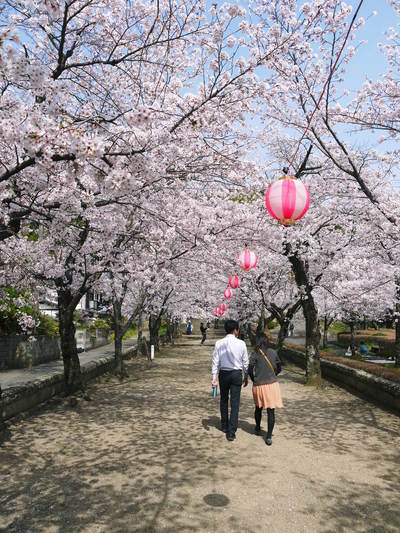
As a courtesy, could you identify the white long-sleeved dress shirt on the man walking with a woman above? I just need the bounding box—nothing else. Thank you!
[211,334,249,379]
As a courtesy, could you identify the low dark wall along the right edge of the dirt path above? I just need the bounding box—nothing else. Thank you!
[282,347,400,414]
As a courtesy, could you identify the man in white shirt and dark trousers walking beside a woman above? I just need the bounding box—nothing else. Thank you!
[211,320,249,441]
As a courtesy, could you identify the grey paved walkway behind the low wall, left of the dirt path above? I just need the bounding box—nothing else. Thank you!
[0,338,136,391]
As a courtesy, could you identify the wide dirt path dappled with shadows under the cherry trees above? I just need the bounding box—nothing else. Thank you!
[0,334,400,533]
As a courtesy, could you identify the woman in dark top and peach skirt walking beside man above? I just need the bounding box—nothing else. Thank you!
[249,336,283,446]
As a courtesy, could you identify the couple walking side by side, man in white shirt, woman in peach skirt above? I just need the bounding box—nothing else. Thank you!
[212,320,283,446]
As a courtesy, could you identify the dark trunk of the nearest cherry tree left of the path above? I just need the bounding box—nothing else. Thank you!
[57,288,83,394]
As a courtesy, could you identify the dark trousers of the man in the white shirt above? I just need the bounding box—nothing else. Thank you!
[219,370,242,435]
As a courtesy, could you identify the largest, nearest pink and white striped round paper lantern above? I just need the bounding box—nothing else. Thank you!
[265,176,310,226]
